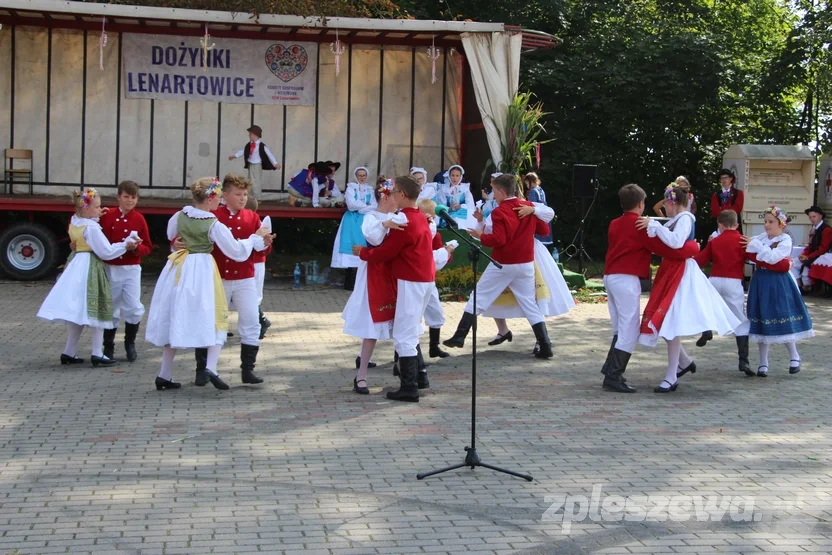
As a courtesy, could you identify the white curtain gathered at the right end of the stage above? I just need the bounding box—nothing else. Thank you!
[462,32,523,167]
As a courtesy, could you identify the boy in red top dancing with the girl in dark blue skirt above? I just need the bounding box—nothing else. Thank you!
[695,210,751,372]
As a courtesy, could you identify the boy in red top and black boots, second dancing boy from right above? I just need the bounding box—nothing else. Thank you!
[601,183,698,393]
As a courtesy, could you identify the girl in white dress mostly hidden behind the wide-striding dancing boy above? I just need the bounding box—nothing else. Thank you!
[484,185,575,354]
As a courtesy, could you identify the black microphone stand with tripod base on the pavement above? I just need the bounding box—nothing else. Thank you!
[416,218,534,482]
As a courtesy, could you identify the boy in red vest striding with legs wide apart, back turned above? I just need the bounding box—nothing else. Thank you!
[444,174,552,358]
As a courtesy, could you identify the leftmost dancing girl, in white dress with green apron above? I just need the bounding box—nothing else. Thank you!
[38,188,142,366]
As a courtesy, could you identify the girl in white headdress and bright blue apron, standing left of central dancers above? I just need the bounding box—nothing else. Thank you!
[331,166,378,268]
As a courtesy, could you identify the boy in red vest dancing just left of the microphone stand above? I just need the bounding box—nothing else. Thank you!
[359,176,436,402]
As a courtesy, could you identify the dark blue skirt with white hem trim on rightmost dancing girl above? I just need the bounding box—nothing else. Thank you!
[747,268,815,343]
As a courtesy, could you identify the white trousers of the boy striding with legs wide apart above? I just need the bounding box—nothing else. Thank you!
[465,262,544,326]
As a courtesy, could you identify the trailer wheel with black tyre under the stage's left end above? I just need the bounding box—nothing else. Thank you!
[0,223,58,281]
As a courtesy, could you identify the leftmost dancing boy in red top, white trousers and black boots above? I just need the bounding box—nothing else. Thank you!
[100,181,153,362]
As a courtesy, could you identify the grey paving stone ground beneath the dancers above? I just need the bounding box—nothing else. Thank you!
[0,277,832,555]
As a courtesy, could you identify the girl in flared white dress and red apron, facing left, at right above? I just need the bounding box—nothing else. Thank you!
[636,183,740,393]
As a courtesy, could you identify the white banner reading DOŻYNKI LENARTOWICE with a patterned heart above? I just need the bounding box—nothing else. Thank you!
[122,33,318,106]
